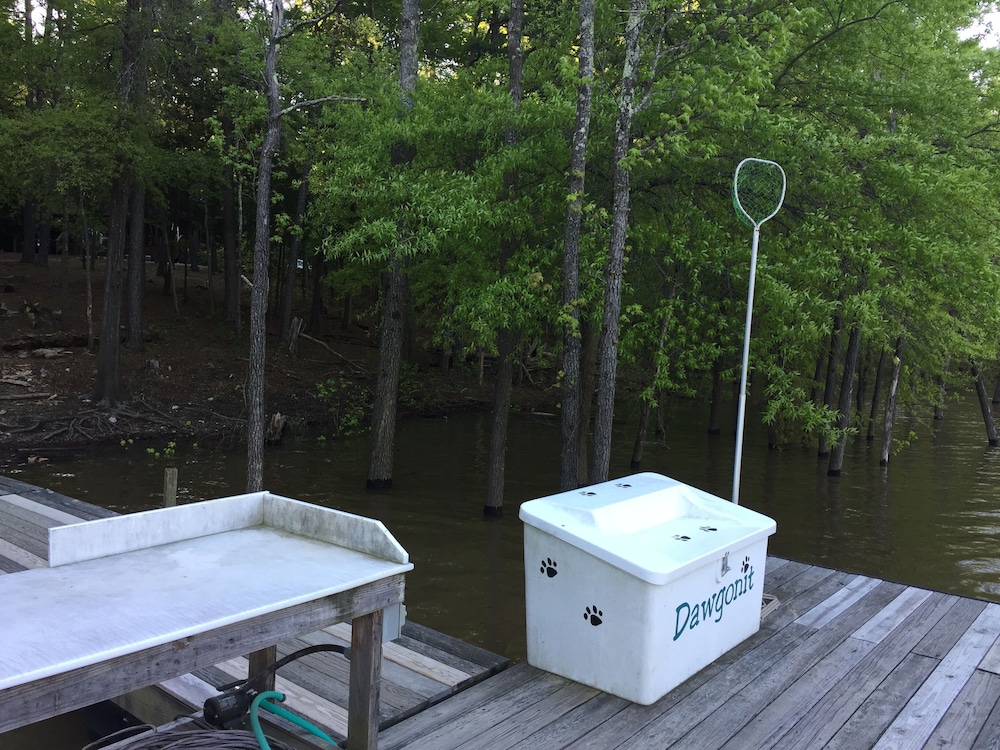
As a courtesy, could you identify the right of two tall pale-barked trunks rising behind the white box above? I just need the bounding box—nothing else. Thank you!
[591,0,649,482]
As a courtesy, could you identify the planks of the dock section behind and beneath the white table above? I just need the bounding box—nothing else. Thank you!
[0,476,507,746]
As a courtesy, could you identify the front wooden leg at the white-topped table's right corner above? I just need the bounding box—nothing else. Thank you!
[347,610,382,750]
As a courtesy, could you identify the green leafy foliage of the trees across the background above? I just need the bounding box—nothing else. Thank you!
[0,0,1000,455]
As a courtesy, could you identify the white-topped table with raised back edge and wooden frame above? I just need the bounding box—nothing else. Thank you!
[0,492,413,748]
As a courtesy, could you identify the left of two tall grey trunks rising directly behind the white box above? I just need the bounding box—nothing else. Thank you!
[559,0,594,490]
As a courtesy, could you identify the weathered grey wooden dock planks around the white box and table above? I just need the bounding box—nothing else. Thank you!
[0,477,1000,750]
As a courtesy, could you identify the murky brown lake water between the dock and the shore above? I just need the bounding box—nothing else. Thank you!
[2,401,1000,659]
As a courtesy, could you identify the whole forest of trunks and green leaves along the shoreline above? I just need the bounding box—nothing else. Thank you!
[0,0,1000,514]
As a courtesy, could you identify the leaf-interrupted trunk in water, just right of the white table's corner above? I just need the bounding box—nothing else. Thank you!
[366,0,420,490]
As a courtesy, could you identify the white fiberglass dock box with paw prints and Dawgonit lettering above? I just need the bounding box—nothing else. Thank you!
[520,473,775,704]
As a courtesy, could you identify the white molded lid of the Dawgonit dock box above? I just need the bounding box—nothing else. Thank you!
[519,472,777,585]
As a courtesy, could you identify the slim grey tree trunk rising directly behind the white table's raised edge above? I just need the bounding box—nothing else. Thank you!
[247,0,285,492]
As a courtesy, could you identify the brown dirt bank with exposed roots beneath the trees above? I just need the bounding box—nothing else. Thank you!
[0,253,555,461]
